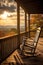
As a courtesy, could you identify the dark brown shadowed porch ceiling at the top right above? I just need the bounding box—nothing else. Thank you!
[15,0,43,14]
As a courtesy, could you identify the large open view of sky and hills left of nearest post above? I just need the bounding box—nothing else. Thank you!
[0,0,17,37]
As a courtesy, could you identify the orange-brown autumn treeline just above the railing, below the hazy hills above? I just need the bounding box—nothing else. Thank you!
[0,28,17,37]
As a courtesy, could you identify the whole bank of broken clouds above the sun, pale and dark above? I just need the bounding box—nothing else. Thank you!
[0,0,16,13]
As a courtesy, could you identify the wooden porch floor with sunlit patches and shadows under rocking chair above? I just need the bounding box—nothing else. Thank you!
[1,38,43,65]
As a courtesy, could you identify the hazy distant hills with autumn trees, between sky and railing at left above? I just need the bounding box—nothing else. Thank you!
[0,26,17,37]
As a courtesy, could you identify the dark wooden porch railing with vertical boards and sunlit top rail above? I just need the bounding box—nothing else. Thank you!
[0,32,42,62]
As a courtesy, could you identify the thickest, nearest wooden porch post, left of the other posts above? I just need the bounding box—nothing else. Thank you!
[17,3,20,44]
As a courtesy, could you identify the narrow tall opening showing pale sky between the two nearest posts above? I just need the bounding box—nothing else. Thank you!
[20,7,25,33]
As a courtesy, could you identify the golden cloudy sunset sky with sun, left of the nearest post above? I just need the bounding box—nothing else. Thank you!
[0,0,17,26]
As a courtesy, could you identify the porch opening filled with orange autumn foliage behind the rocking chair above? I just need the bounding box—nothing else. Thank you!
[30,14,43,36]
